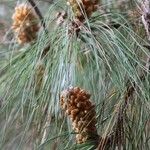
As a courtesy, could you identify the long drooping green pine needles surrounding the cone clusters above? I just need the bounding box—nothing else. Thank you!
[0,0,150,150]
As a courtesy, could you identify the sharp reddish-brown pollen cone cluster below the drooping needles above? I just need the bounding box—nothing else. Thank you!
[60,87,98,144]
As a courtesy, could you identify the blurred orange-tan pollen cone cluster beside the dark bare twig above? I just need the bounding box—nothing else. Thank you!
[12,4,39,44]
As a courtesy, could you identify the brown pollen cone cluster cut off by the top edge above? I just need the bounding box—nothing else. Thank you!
[67,0,99,22]
